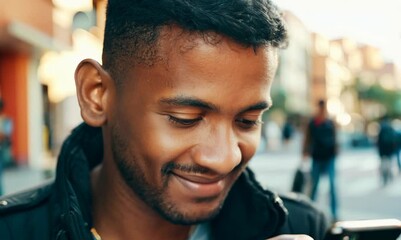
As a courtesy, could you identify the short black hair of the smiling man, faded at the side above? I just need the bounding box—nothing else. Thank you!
[103,0,287,82]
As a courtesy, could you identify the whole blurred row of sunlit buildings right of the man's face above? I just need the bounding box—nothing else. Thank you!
[272,12,401,144]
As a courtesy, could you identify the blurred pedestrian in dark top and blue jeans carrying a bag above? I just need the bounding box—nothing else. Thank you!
[303,100,338,221]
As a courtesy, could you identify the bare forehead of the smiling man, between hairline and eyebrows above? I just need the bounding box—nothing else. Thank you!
[122,27,277,110]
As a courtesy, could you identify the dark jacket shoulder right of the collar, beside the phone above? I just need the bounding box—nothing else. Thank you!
[279,193,329,240]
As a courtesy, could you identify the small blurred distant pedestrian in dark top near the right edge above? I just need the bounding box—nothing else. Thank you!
[376,117,397,186]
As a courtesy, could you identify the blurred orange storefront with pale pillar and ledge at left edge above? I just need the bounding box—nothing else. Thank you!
[0,0,70,165]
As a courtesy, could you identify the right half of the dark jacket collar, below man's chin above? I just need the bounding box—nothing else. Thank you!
[212,168,287,239]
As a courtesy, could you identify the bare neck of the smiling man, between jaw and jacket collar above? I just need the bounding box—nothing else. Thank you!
[91,163,191,240]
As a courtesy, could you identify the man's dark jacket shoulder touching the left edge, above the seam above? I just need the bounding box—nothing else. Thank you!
[0,180,53,216]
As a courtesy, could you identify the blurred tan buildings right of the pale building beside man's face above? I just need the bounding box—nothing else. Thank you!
[310,33,400,132]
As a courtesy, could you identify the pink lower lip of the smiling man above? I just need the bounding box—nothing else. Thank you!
[173,175,224,197]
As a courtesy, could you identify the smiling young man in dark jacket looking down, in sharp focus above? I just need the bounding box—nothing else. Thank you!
[0,0,326,240]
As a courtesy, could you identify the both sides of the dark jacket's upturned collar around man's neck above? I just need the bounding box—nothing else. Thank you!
[55,123,287,239]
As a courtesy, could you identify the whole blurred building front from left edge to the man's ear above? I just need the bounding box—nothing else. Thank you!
[0,0,106,168]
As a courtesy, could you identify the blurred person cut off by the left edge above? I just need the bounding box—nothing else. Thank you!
[0,99,13,195]
